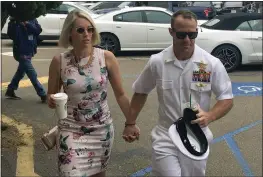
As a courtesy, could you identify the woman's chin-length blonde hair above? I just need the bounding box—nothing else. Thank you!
[58,10,100,48]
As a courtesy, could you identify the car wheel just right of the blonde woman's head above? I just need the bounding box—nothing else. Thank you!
[100,33,120,54]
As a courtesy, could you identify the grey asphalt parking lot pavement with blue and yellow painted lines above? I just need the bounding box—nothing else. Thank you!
[1,41,262,176]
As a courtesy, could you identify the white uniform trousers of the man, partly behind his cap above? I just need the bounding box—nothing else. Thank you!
[151,125,213,177]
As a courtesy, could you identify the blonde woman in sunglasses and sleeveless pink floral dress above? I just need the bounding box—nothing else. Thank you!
[48,10,139,177]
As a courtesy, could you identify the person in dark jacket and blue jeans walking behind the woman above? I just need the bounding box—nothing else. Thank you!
[5,18,47,103]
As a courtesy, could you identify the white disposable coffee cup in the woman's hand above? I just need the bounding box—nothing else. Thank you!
[53,93,68,119]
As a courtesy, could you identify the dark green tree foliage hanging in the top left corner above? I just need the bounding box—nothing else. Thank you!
[1,1,62,29]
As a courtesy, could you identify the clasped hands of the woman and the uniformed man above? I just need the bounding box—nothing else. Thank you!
[122,124,140,143]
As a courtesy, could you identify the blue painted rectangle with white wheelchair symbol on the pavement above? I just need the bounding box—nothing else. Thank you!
[232,82,262,96]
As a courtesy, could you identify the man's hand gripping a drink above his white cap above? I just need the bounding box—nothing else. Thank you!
[191,107,215,128]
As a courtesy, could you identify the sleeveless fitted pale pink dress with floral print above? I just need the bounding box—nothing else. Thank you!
[57,48,114,177]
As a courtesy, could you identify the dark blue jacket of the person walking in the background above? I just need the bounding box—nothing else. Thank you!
[7,19,42,59]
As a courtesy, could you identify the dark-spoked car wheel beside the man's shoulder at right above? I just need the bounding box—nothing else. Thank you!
[212,45,241,72]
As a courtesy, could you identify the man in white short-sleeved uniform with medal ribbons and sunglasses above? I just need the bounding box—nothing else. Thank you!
[123,10,233,176]
